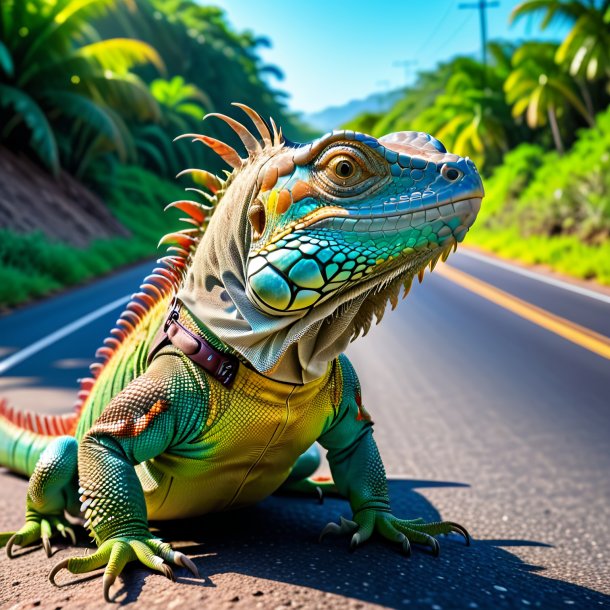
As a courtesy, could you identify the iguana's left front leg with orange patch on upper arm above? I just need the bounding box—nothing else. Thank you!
[49,355,204,601]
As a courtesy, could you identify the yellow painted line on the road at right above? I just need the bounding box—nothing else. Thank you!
[435,265,610,360]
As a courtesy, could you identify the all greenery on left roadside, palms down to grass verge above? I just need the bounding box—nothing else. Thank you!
[0,0,310,306]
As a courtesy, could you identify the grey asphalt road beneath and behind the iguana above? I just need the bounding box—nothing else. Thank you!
[0,253,610,610]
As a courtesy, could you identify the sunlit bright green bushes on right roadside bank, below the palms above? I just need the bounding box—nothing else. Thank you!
[468,108,610,285]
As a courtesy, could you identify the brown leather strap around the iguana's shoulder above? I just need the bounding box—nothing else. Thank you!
[148,298,239,388]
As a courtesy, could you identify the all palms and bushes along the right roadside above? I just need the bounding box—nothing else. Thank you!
[346,0,610,285]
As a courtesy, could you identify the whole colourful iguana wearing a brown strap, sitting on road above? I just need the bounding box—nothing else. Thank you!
[0,104,483,600]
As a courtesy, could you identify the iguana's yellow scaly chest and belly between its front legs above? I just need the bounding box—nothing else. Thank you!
[136,361,343,519]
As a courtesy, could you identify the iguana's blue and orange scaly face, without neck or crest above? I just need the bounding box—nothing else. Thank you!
[240,124,483,315]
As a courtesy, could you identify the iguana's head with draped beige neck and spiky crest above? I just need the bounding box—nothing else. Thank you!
[173,105,483,383]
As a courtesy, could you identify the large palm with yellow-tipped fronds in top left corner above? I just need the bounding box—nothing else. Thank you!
[0,0,163,175]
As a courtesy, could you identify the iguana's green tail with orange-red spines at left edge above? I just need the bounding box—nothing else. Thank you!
[0,399,78,476]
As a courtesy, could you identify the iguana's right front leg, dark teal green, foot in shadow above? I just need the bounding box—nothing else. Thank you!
[319,357,470,555]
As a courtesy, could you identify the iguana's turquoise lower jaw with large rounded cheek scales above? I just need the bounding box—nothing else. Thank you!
[247,190,482,316]
